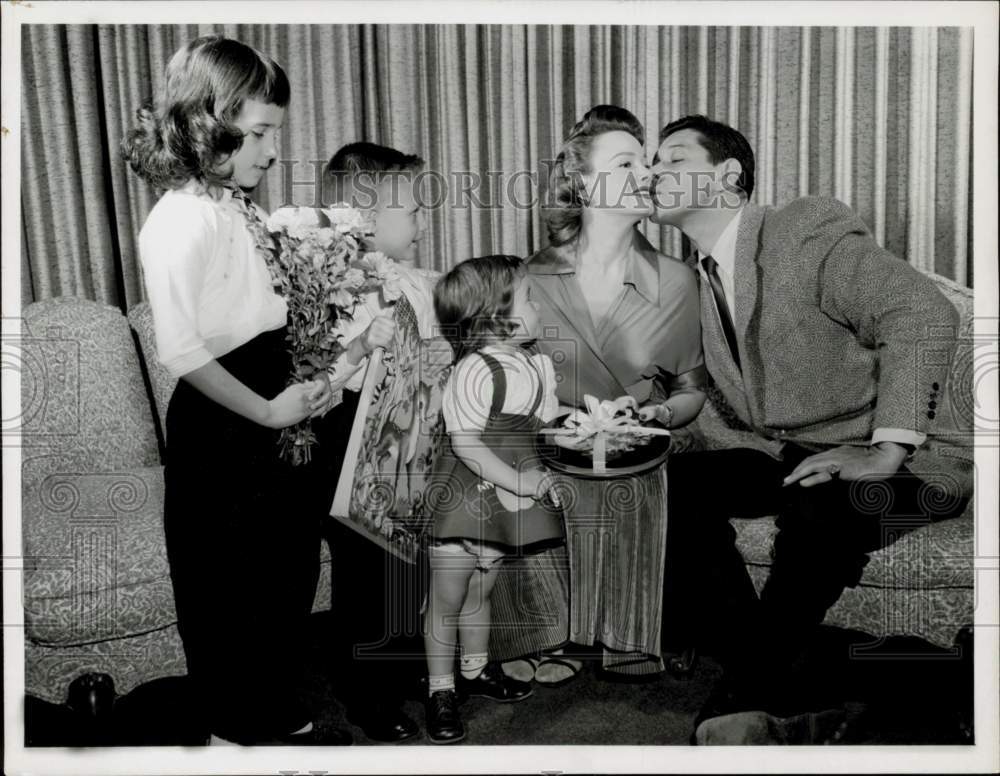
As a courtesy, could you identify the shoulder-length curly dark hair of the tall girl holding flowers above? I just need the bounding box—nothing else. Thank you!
[121,35,291,190]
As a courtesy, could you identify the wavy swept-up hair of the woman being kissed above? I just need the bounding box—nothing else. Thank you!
[543,105,646,247]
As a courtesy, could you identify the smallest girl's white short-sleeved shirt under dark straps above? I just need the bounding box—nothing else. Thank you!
[441,347,559,433]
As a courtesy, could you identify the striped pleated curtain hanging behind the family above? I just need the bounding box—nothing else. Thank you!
[21,25,973,308]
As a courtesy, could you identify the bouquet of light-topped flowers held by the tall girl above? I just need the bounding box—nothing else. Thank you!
[258,206,402,465]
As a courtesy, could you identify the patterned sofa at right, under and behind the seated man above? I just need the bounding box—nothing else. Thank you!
[691,273,975,649]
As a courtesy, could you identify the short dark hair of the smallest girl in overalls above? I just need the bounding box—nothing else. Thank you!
[434,255,527,363]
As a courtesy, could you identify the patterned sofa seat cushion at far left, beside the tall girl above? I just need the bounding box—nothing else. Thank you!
[21,457,176,645]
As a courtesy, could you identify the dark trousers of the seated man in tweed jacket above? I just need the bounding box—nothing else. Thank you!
[663,445,965,708]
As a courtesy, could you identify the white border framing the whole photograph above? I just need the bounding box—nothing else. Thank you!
[0,0,1000,776]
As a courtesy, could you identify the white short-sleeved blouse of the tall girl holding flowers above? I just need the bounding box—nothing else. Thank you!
[139,182,288,377]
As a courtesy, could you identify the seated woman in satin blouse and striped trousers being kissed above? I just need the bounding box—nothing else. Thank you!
[508,105,705,682]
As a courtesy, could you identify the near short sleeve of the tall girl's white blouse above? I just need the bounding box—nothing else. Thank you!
[139,194,216,377]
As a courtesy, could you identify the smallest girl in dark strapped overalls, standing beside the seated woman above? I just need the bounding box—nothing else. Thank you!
[424,256,564,743]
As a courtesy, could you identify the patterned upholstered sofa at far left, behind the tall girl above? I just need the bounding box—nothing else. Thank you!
[20,297,330,703]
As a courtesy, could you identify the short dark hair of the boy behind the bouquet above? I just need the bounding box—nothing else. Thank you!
[323,142,425,208]
